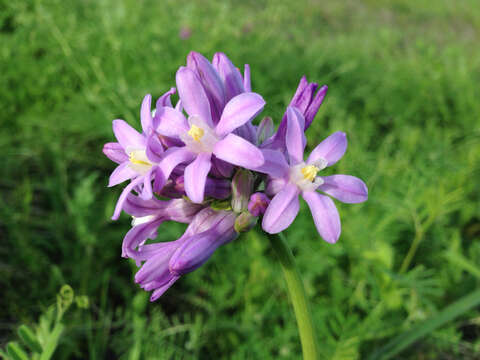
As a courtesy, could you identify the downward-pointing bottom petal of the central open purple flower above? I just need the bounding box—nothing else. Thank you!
[185,153,212,203]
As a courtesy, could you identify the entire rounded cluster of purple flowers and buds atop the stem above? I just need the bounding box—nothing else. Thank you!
[103,52,368,301]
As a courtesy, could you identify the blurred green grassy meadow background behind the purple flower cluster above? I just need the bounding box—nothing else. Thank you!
[0,0,480,360]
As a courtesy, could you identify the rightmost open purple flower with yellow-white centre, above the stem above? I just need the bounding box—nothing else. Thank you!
[262,107,368,243]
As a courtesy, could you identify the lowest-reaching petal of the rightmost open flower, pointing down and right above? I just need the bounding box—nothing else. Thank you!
[302,191,341,244]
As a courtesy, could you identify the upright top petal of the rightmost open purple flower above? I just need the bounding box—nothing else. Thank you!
[285,106,307,165]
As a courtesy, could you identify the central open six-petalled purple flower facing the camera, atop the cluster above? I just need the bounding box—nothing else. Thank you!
[154,63,265,203]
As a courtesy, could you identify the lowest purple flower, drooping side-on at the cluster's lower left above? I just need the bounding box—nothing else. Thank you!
[130,205,238,301]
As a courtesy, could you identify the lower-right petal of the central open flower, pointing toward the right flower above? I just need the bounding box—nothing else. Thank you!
[213,134,265,169]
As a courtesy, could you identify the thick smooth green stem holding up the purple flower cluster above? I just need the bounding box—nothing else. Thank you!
[267,233,319,360]
